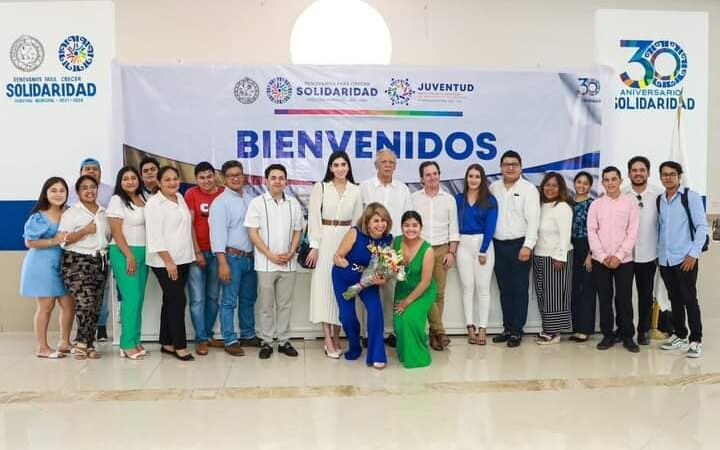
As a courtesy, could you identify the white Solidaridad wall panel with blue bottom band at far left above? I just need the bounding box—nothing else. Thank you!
[0,2,114,250]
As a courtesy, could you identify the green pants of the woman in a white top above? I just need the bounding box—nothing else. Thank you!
[110,244,148,350]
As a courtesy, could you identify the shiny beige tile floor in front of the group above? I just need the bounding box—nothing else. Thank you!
[0,320,720,450]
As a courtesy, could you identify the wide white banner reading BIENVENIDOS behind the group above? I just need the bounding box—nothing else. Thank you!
[119,65,610,207]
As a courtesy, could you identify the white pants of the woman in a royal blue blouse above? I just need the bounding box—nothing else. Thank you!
[456,234,495,328]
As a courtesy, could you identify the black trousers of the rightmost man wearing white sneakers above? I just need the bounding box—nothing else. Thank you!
[660,262,702,342]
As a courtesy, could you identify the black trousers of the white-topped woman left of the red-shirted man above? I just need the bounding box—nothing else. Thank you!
[152,264,190,350]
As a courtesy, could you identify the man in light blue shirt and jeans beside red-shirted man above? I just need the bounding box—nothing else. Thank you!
[208,160,260,356]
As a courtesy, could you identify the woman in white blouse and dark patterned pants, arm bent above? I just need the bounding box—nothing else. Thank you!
[58,175,110,359]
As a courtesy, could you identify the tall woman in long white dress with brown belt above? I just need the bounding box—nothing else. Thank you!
[306,151,363,359]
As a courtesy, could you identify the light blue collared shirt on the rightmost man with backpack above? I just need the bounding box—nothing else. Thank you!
[652,186,708,266]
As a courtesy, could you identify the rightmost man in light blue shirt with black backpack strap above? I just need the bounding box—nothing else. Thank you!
[658,161,708,358]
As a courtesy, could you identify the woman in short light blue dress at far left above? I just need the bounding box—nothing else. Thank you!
[20,177,75,359]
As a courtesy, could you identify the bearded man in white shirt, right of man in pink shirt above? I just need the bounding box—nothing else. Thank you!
[625,156,663,345]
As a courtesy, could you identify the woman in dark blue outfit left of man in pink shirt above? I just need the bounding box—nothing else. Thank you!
[570,171,596,342]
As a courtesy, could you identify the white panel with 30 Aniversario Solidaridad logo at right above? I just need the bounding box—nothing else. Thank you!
[595,9,717,199]
